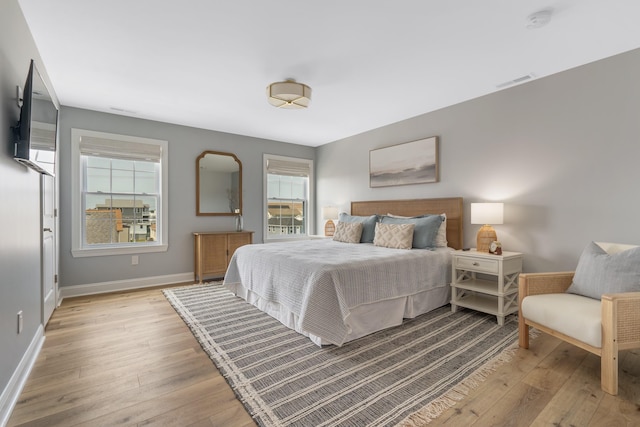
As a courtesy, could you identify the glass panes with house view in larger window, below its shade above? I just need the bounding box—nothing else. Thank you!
[82,155,160,245]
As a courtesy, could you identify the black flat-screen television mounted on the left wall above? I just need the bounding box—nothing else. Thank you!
[13,60,58,176]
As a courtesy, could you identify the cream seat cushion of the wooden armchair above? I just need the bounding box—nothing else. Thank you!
[520,294,602,348]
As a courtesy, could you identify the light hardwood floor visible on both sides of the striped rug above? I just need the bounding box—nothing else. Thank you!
[8,289,640,427]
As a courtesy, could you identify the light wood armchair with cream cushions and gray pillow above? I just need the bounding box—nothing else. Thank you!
[518,242,640,395]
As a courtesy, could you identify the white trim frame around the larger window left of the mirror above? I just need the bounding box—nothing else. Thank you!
[71,129,169,258]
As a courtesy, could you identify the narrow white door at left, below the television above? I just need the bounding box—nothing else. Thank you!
[40,174,58,325]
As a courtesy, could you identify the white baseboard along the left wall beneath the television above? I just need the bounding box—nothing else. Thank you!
[0,325,45,426]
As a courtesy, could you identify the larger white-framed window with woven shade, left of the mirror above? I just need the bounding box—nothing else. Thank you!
[71,129,168,257]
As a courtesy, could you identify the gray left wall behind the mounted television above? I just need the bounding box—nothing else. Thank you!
[0,0,55,410]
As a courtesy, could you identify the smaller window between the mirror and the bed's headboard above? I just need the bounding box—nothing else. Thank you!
[264,154,313,240]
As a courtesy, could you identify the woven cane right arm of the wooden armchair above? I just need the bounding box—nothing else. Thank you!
[602,292,640,349]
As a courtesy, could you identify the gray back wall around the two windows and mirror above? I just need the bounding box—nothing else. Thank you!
[58,107,315,288]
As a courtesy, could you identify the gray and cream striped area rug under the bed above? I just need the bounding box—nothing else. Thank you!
[164,284,518,427]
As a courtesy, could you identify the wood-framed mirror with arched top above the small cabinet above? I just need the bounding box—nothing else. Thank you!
[196,151,242,216]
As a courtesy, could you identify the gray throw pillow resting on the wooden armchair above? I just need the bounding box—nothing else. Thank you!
[567,242,640,299]
